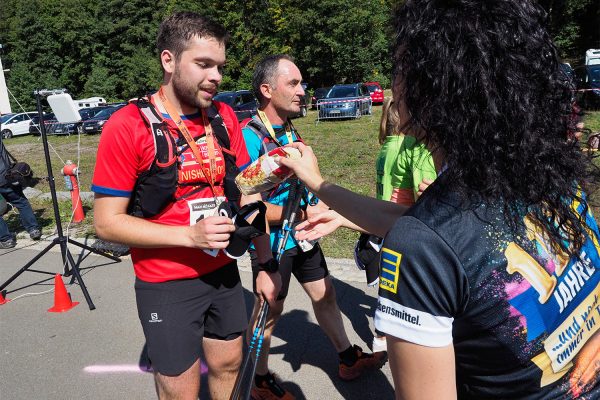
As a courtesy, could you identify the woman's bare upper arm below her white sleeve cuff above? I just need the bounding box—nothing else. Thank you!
[386,335,457,400]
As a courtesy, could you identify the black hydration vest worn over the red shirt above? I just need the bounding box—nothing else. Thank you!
[127,99,241,218]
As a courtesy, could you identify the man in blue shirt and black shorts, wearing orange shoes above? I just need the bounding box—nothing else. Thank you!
[242,54,386,400]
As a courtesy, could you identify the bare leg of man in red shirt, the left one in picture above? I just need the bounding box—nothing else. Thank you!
[154,360,200,400]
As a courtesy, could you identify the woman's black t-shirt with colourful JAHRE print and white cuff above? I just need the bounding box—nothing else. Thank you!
[375,175,600,399]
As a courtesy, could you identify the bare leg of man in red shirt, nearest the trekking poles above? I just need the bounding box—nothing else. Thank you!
[202,336,242,400]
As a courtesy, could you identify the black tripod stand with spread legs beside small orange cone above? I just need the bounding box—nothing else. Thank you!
[0,89,121,310]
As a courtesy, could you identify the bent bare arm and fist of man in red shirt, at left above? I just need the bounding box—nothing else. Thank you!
[94,193,235,249]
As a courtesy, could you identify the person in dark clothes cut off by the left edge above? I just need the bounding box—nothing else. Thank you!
[0,115,42,249]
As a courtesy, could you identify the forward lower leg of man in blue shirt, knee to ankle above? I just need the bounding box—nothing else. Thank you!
[302,276,350,353]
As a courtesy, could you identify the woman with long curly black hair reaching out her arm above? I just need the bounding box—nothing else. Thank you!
[281,0,600,399]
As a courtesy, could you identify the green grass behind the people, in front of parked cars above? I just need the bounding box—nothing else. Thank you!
[5,109,600,258]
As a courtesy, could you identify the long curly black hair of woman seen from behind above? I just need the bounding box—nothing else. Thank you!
[393,0,598,254]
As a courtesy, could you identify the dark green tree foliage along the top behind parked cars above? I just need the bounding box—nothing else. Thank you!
[0,0,600,110]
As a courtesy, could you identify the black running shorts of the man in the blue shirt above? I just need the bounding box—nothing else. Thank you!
[250,243,329,299]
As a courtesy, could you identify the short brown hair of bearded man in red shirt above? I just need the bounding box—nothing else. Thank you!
[156,11,229,65]
